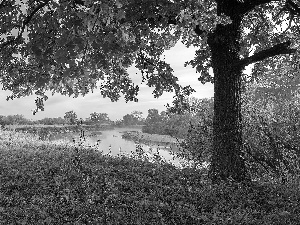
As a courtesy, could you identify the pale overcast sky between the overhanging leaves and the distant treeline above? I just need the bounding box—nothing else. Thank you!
[0,42,213,120]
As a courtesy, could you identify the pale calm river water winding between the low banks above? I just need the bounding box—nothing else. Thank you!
[51,128,195,168]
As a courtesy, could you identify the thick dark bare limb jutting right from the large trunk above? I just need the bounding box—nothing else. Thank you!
[234,41,297,67]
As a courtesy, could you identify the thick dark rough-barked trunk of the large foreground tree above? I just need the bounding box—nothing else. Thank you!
[208,18,247,183]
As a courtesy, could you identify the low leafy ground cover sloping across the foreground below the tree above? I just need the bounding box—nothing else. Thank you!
[0,130,300,224]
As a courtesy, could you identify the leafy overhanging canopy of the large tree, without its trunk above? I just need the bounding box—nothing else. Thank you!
[0,0,300,109]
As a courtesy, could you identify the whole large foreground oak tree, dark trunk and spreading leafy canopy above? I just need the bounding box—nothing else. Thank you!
[0,0,300,182]
